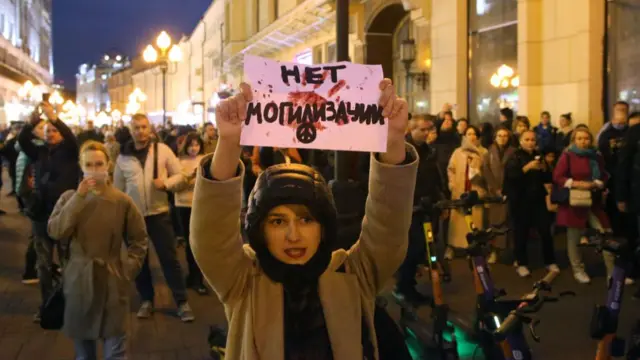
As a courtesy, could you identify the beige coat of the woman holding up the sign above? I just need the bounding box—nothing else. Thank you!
[191,145,418,360]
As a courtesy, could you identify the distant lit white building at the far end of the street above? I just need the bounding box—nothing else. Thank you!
[76,54,131,118]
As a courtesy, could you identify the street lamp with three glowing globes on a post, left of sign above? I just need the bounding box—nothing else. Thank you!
[142,31,182,127]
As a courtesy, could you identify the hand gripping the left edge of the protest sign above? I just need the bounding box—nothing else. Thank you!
[216,83,253,143]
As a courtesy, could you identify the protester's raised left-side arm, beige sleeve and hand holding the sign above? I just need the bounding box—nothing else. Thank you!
[190,84,253,303]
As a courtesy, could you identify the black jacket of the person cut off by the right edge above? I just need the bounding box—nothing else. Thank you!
[613,125,640,213]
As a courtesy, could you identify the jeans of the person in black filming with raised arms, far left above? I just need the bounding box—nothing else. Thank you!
[31,221,65,305]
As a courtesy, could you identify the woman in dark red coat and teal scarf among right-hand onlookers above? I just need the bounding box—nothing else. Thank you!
[553,127,632,284]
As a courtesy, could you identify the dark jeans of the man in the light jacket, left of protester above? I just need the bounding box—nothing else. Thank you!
[136,213,187,306]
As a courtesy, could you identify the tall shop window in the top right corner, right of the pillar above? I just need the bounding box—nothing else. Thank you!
[605,0,640,118]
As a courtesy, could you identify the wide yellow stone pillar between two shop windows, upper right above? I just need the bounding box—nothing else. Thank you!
[536,0,605,132]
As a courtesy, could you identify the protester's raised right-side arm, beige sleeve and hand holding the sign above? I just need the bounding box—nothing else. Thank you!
[348,79,419,296]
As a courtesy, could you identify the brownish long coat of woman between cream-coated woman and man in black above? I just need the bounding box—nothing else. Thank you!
[482,144,516,249]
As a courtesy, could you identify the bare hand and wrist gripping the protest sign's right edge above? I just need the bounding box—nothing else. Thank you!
[379,79,409,164]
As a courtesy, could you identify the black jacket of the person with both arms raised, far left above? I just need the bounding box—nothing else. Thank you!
[18,120,81,218]
